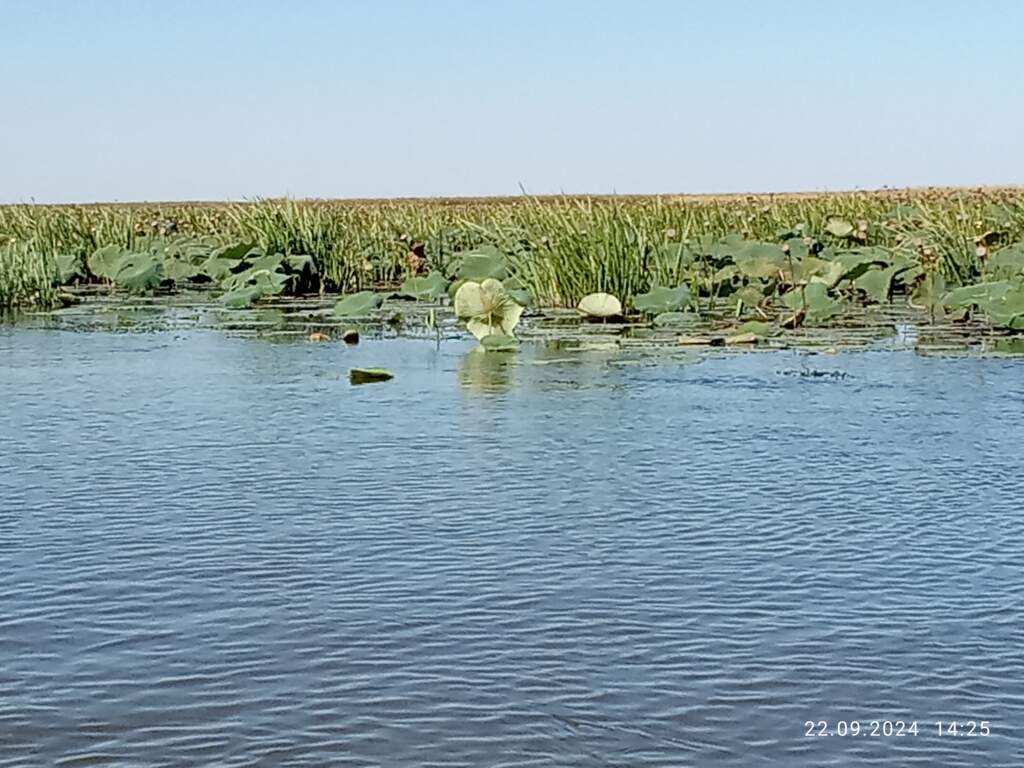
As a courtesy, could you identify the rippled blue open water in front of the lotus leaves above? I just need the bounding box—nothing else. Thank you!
[0,328,1024,766]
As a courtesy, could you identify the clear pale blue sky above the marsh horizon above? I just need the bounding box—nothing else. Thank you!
[0,0,1024,203]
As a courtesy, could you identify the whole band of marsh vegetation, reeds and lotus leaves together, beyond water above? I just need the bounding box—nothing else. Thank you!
[6,189,1024,339]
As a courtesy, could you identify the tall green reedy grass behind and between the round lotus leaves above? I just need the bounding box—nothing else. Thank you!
[0,189,1024,305]
